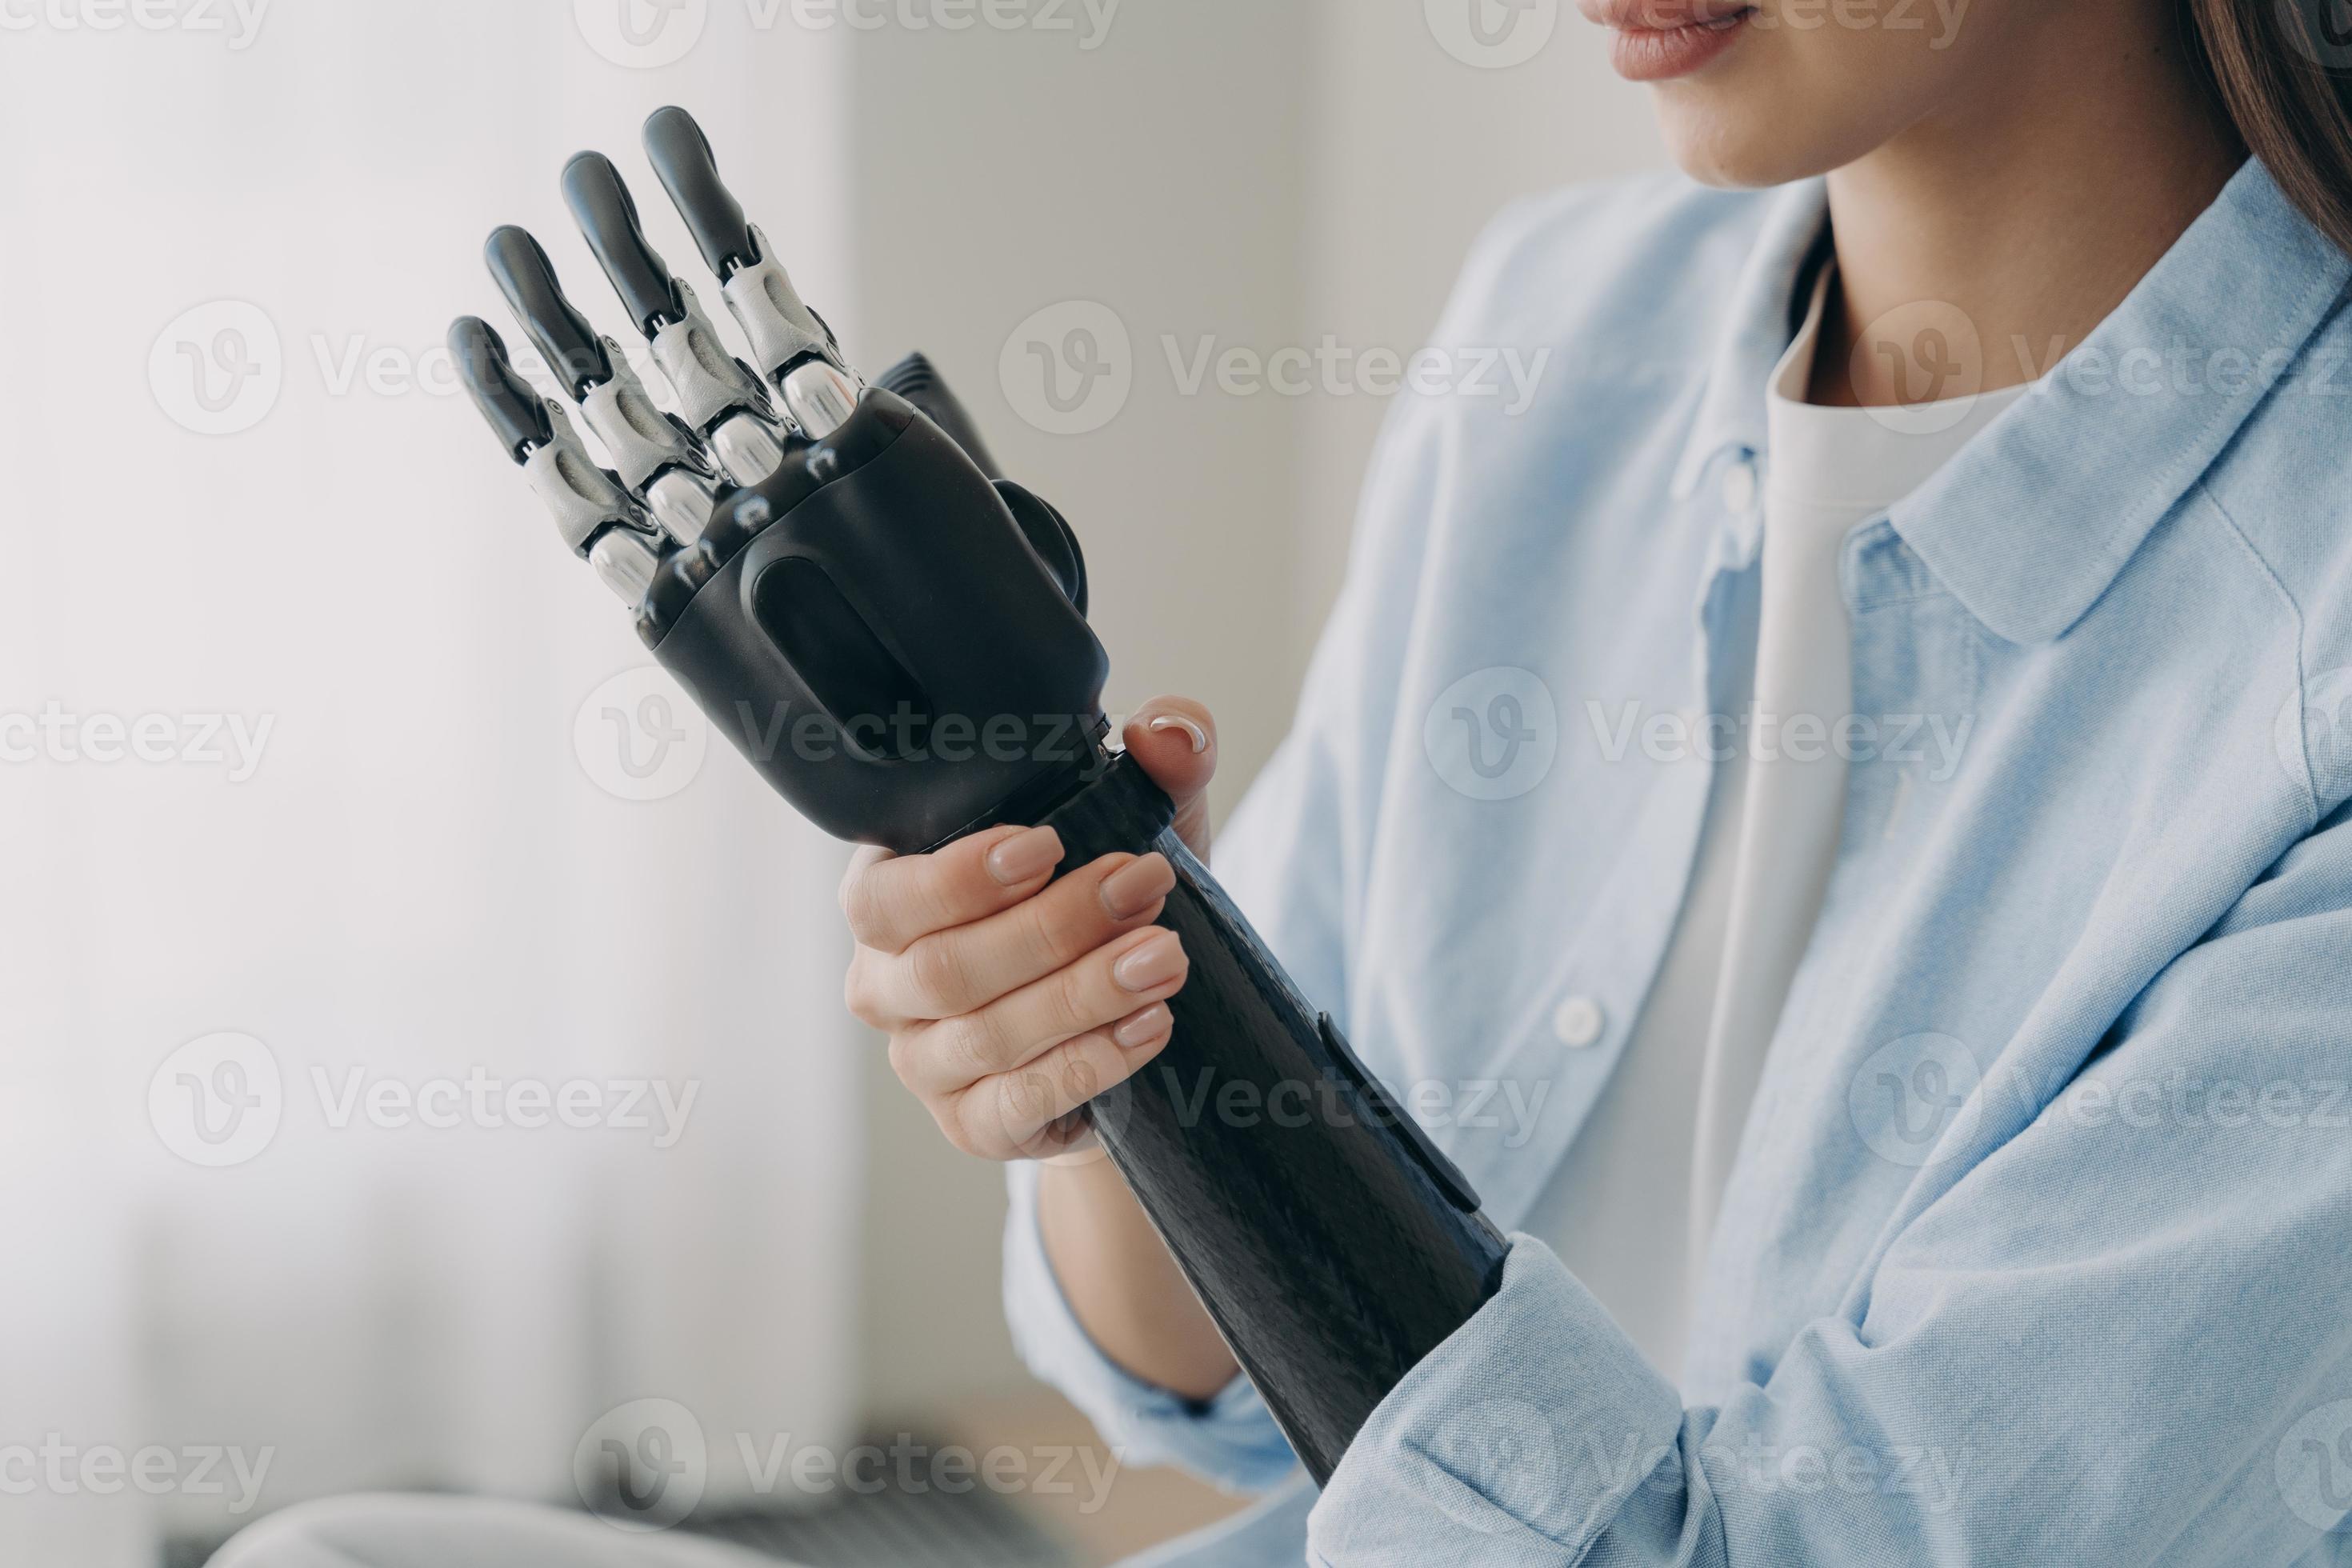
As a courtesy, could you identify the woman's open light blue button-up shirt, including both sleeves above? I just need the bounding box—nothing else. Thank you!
[1006,165,2352,1568]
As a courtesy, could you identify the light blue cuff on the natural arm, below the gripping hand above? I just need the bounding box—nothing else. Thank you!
[1004,1162,1296,1493]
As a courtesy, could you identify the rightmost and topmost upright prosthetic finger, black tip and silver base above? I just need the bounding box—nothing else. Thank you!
[645,106,861,438]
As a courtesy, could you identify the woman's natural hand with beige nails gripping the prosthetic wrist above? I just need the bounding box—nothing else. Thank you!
[842,698,1216,1159]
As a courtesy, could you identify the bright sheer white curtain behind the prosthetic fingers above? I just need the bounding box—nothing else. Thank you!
[0,0,858,1568]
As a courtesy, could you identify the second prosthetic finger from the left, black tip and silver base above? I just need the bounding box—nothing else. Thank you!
[482,223,726,543]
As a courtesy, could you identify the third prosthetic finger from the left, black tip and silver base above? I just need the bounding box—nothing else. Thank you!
[562,153,788,484]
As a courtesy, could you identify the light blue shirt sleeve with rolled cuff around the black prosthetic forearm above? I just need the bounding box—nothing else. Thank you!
[1310,811,2352,1568]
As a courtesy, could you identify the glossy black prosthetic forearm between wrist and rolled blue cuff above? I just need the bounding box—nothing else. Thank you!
[1044,757,1510,1486]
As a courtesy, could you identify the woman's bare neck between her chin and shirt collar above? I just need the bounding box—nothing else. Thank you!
[1809,5,2244,406]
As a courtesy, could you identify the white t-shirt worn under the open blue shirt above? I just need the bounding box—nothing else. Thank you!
[1524,268,2025,1375]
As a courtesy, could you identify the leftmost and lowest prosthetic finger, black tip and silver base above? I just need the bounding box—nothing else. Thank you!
[450,315,673,604]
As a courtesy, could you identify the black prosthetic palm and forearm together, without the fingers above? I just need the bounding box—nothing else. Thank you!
[640,366,1508,1483]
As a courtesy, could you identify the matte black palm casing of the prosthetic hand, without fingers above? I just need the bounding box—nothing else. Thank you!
[640,388,1110,854]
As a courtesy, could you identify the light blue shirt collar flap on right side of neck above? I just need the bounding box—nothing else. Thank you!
[1889,160,2352,644]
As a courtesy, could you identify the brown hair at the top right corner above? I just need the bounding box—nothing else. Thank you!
[2180,0,2352,251]
